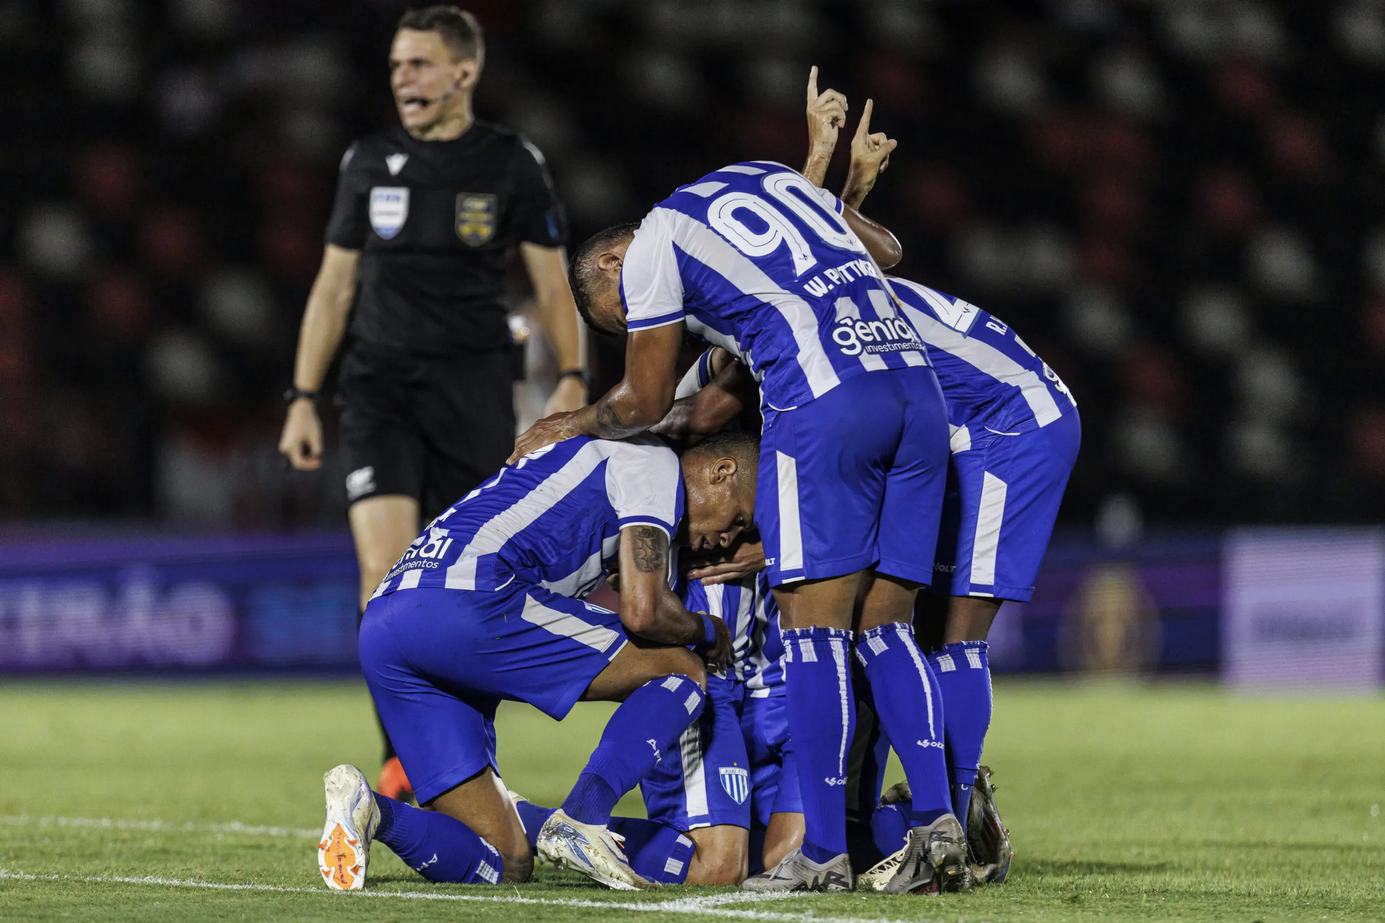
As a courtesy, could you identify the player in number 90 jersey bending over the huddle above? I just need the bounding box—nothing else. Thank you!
[515,69,967,891]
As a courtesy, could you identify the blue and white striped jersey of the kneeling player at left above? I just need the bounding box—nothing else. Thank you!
[375,437,683,599]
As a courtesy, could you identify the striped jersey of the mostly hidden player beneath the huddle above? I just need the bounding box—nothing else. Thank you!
[680,571,784,696]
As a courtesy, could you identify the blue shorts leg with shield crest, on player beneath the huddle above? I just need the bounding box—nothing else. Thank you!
[640,676,751,833]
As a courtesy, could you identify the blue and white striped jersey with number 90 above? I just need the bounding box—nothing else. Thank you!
[620,161,928,410]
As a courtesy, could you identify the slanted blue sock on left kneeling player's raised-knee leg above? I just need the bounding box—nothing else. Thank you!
[562,676,705,823]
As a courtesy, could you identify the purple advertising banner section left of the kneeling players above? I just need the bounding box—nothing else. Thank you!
[0,534,357,674]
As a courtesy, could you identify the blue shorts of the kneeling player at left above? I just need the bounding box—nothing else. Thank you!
[360,583,626,804]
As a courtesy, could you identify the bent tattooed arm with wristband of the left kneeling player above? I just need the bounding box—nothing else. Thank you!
[620,525,731,664]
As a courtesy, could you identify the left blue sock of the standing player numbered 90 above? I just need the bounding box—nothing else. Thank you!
[784,626,856,862]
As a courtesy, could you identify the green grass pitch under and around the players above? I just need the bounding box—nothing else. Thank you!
[0,680,1385,923]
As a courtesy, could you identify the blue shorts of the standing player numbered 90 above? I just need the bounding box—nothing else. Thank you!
[755,366,947,586]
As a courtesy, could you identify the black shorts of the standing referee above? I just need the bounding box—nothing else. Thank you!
[337,344,515,522]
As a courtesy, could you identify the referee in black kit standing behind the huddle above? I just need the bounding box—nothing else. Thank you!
[278,6,587,798]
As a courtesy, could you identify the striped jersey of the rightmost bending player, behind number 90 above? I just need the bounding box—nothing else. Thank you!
[889,276,1078,452]
